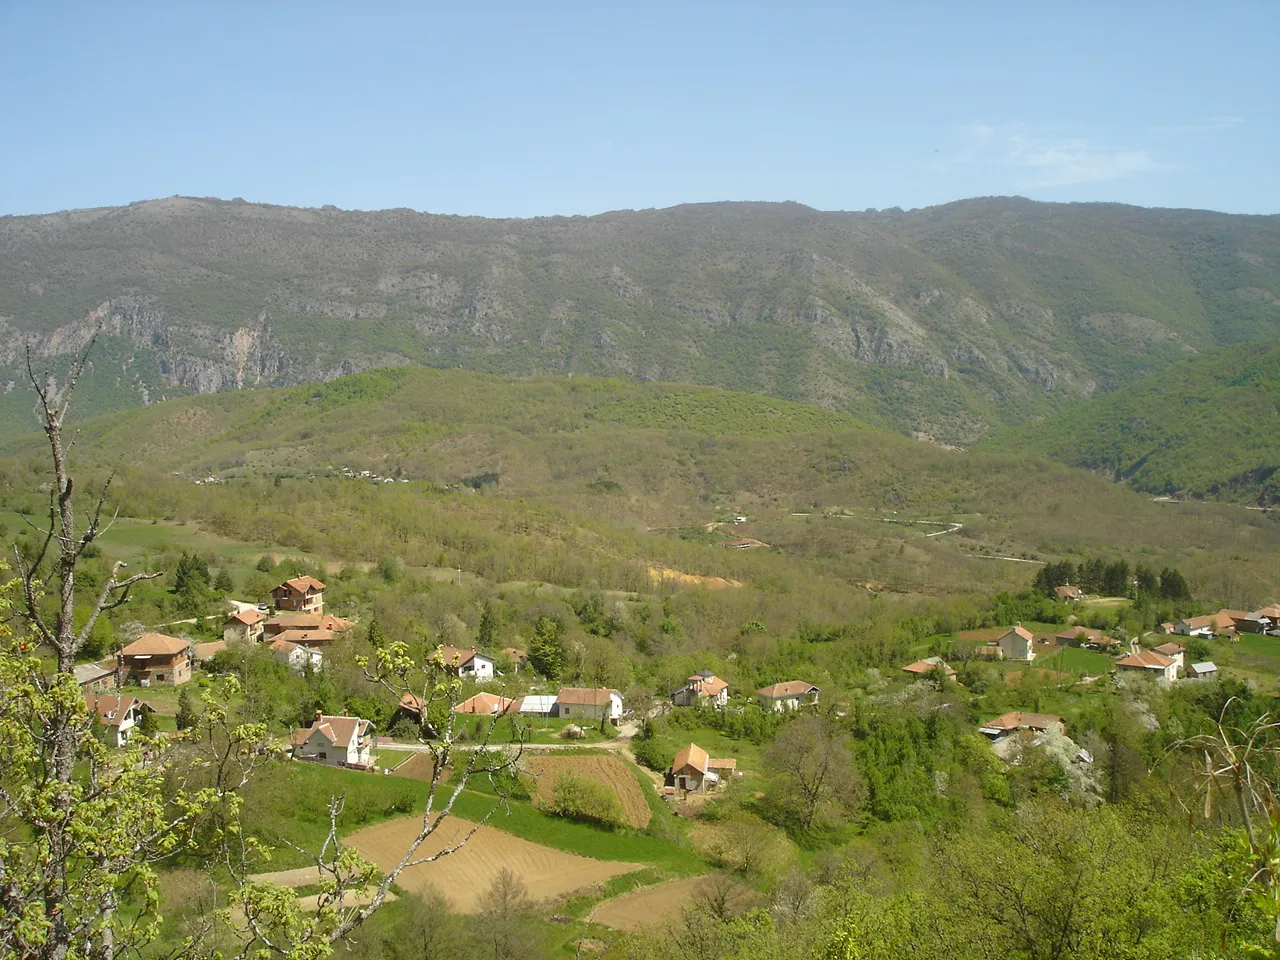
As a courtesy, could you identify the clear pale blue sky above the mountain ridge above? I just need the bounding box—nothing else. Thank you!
[0,0,1280,216]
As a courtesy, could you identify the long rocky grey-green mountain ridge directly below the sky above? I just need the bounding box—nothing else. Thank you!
[0,197,1280,444]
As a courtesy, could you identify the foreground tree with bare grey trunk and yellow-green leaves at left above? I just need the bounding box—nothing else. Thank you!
[0,339,518,960]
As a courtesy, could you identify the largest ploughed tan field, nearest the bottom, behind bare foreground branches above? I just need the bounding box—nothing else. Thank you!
[347,817,641,913]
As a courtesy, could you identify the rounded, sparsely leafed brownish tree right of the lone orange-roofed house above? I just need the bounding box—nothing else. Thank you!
[764,716,865,833]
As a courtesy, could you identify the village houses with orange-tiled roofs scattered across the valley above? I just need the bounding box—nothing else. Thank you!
[76,576,1280,801]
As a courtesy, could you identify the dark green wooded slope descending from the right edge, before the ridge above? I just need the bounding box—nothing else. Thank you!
[989,343,1280,504]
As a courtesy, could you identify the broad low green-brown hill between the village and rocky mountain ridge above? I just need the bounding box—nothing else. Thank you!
[10,367,1280,602]
